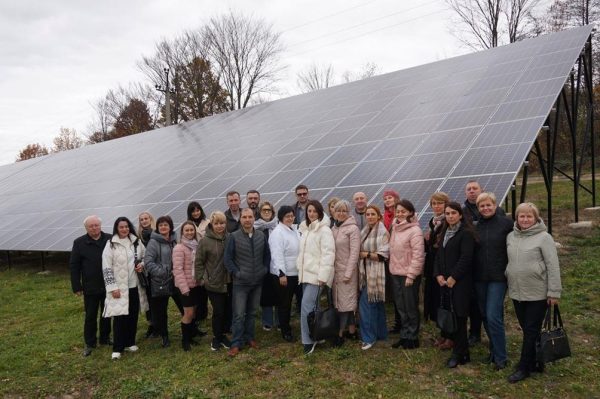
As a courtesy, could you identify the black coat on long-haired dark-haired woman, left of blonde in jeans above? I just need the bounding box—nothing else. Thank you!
[433,226,475,317]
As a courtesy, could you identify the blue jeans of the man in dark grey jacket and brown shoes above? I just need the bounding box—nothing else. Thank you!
[231,284,262,348]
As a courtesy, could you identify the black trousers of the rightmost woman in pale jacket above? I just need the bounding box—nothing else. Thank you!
[513,299,548,371]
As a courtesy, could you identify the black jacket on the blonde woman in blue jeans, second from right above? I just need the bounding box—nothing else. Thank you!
[473,213,514,281]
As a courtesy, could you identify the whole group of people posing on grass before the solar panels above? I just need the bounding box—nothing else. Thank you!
[70,181,561,382]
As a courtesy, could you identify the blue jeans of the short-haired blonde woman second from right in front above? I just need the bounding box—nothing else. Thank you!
[475,281,507,364]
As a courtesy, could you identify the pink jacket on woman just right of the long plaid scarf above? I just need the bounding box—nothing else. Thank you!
[390,221,425,280]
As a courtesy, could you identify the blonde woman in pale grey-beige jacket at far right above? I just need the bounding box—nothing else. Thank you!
[506,202,562,383]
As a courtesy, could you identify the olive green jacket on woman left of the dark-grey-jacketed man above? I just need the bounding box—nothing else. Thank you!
[194,228,231,293]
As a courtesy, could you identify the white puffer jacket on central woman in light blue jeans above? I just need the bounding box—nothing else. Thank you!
[296,215,335,287]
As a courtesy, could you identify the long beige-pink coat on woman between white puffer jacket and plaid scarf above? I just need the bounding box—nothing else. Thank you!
[331,216,360,312]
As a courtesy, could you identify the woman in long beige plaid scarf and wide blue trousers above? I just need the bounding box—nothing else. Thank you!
[358,205,390,350]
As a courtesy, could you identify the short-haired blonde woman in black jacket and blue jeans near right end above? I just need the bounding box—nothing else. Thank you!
[473,193,513,370]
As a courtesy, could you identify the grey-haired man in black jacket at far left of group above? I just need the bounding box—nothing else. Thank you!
[69,215,112,356]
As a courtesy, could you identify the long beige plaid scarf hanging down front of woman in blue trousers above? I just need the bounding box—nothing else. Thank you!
[358,222,390,303]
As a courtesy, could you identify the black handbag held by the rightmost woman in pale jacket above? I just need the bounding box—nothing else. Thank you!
[536,305,571,363]
